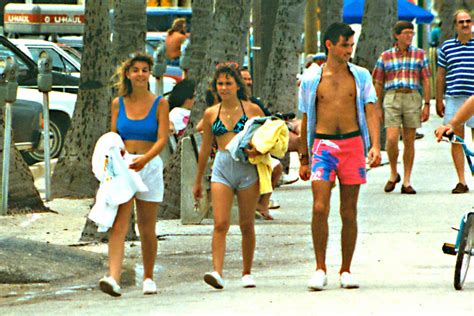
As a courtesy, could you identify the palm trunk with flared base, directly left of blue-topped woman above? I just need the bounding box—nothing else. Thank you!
[52,1,112,198]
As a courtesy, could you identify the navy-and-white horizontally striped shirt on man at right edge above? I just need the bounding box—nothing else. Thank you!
[438,38,474,96]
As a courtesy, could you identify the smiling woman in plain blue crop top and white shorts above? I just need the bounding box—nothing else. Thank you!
[99,53,169,296]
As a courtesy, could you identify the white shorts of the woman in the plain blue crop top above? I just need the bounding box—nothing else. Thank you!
[125,153,165,203]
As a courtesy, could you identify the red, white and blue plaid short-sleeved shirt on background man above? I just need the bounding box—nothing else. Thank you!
[372,45,431,90]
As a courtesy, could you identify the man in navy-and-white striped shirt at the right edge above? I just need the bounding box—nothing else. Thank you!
[436,10,474,193]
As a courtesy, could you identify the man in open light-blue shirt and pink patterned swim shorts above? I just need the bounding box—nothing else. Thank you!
[298,22,381,291]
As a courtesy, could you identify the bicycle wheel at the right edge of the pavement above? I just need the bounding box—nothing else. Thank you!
[454,214,474,290]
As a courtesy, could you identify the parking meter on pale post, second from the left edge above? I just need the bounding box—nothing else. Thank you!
[38,51,53,201]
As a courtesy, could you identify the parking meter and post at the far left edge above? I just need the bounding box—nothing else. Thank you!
[0,59,11,215]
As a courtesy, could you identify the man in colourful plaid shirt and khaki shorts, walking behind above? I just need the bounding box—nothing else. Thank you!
[372,21,431,194]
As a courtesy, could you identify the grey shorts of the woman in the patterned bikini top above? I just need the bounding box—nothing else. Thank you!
[211,150,258,191]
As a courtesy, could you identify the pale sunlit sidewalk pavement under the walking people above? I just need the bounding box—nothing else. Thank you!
[0,114,474,315]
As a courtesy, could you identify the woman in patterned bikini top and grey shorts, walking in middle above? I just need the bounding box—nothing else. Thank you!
[193,64,264,289]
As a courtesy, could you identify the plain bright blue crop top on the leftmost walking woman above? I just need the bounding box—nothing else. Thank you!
[117,97,161,142]
